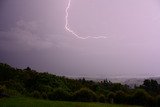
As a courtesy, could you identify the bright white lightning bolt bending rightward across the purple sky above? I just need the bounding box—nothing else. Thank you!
[65,0,107,39]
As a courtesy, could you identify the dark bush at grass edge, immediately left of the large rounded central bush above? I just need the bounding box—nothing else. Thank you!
[48,88,70,101]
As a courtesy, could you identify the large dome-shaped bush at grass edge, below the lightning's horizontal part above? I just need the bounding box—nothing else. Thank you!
[73,88,97,102]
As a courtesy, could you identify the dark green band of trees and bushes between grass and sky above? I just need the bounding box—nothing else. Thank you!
[0,63,160,107]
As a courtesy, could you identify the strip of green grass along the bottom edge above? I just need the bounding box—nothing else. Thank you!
[0,97,142,107]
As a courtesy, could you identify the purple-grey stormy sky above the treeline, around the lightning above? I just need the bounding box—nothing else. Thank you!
[0,0,160,78]
